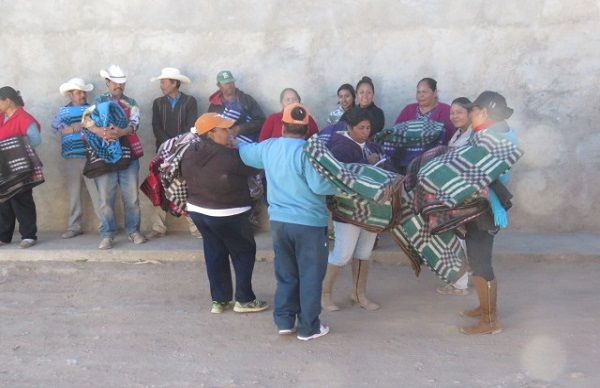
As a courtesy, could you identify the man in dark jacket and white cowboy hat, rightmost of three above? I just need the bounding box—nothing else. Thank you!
[146,67,202,239]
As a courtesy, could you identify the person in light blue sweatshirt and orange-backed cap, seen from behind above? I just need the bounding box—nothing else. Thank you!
[240,104,337,341]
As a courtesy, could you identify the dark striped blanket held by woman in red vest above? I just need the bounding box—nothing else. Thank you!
[0,136,44,202]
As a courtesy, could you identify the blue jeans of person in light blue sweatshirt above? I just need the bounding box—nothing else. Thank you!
[271,221,329,336]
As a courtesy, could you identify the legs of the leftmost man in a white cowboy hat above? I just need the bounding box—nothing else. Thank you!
[63,158,101,237]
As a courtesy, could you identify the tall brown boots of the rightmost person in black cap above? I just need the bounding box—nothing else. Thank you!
[460,276,502,334]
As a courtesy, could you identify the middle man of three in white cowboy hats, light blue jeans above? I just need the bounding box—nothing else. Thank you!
[90,65,146,249]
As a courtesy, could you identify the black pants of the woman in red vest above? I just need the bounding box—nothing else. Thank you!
[0,189,37,243]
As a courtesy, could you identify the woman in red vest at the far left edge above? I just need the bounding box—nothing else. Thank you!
[0,86,42,248]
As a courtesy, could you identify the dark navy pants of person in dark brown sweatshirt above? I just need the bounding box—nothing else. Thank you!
[189,212,256,303]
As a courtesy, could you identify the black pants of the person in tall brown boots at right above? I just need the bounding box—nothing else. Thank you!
[465,222,495,281]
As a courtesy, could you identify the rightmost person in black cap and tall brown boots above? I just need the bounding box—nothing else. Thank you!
[461,91,517,334]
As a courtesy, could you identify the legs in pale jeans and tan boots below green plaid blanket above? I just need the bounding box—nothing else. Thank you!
[321,221,380,311]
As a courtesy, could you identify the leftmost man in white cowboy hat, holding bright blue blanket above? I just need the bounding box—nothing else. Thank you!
[52,78,98,238]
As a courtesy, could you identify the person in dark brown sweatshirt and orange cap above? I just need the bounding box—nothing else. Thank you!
[181,113,269,314]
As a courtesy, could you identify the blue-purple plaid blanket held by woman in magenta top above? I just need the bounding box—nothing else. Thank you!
[374,117,444,157]
